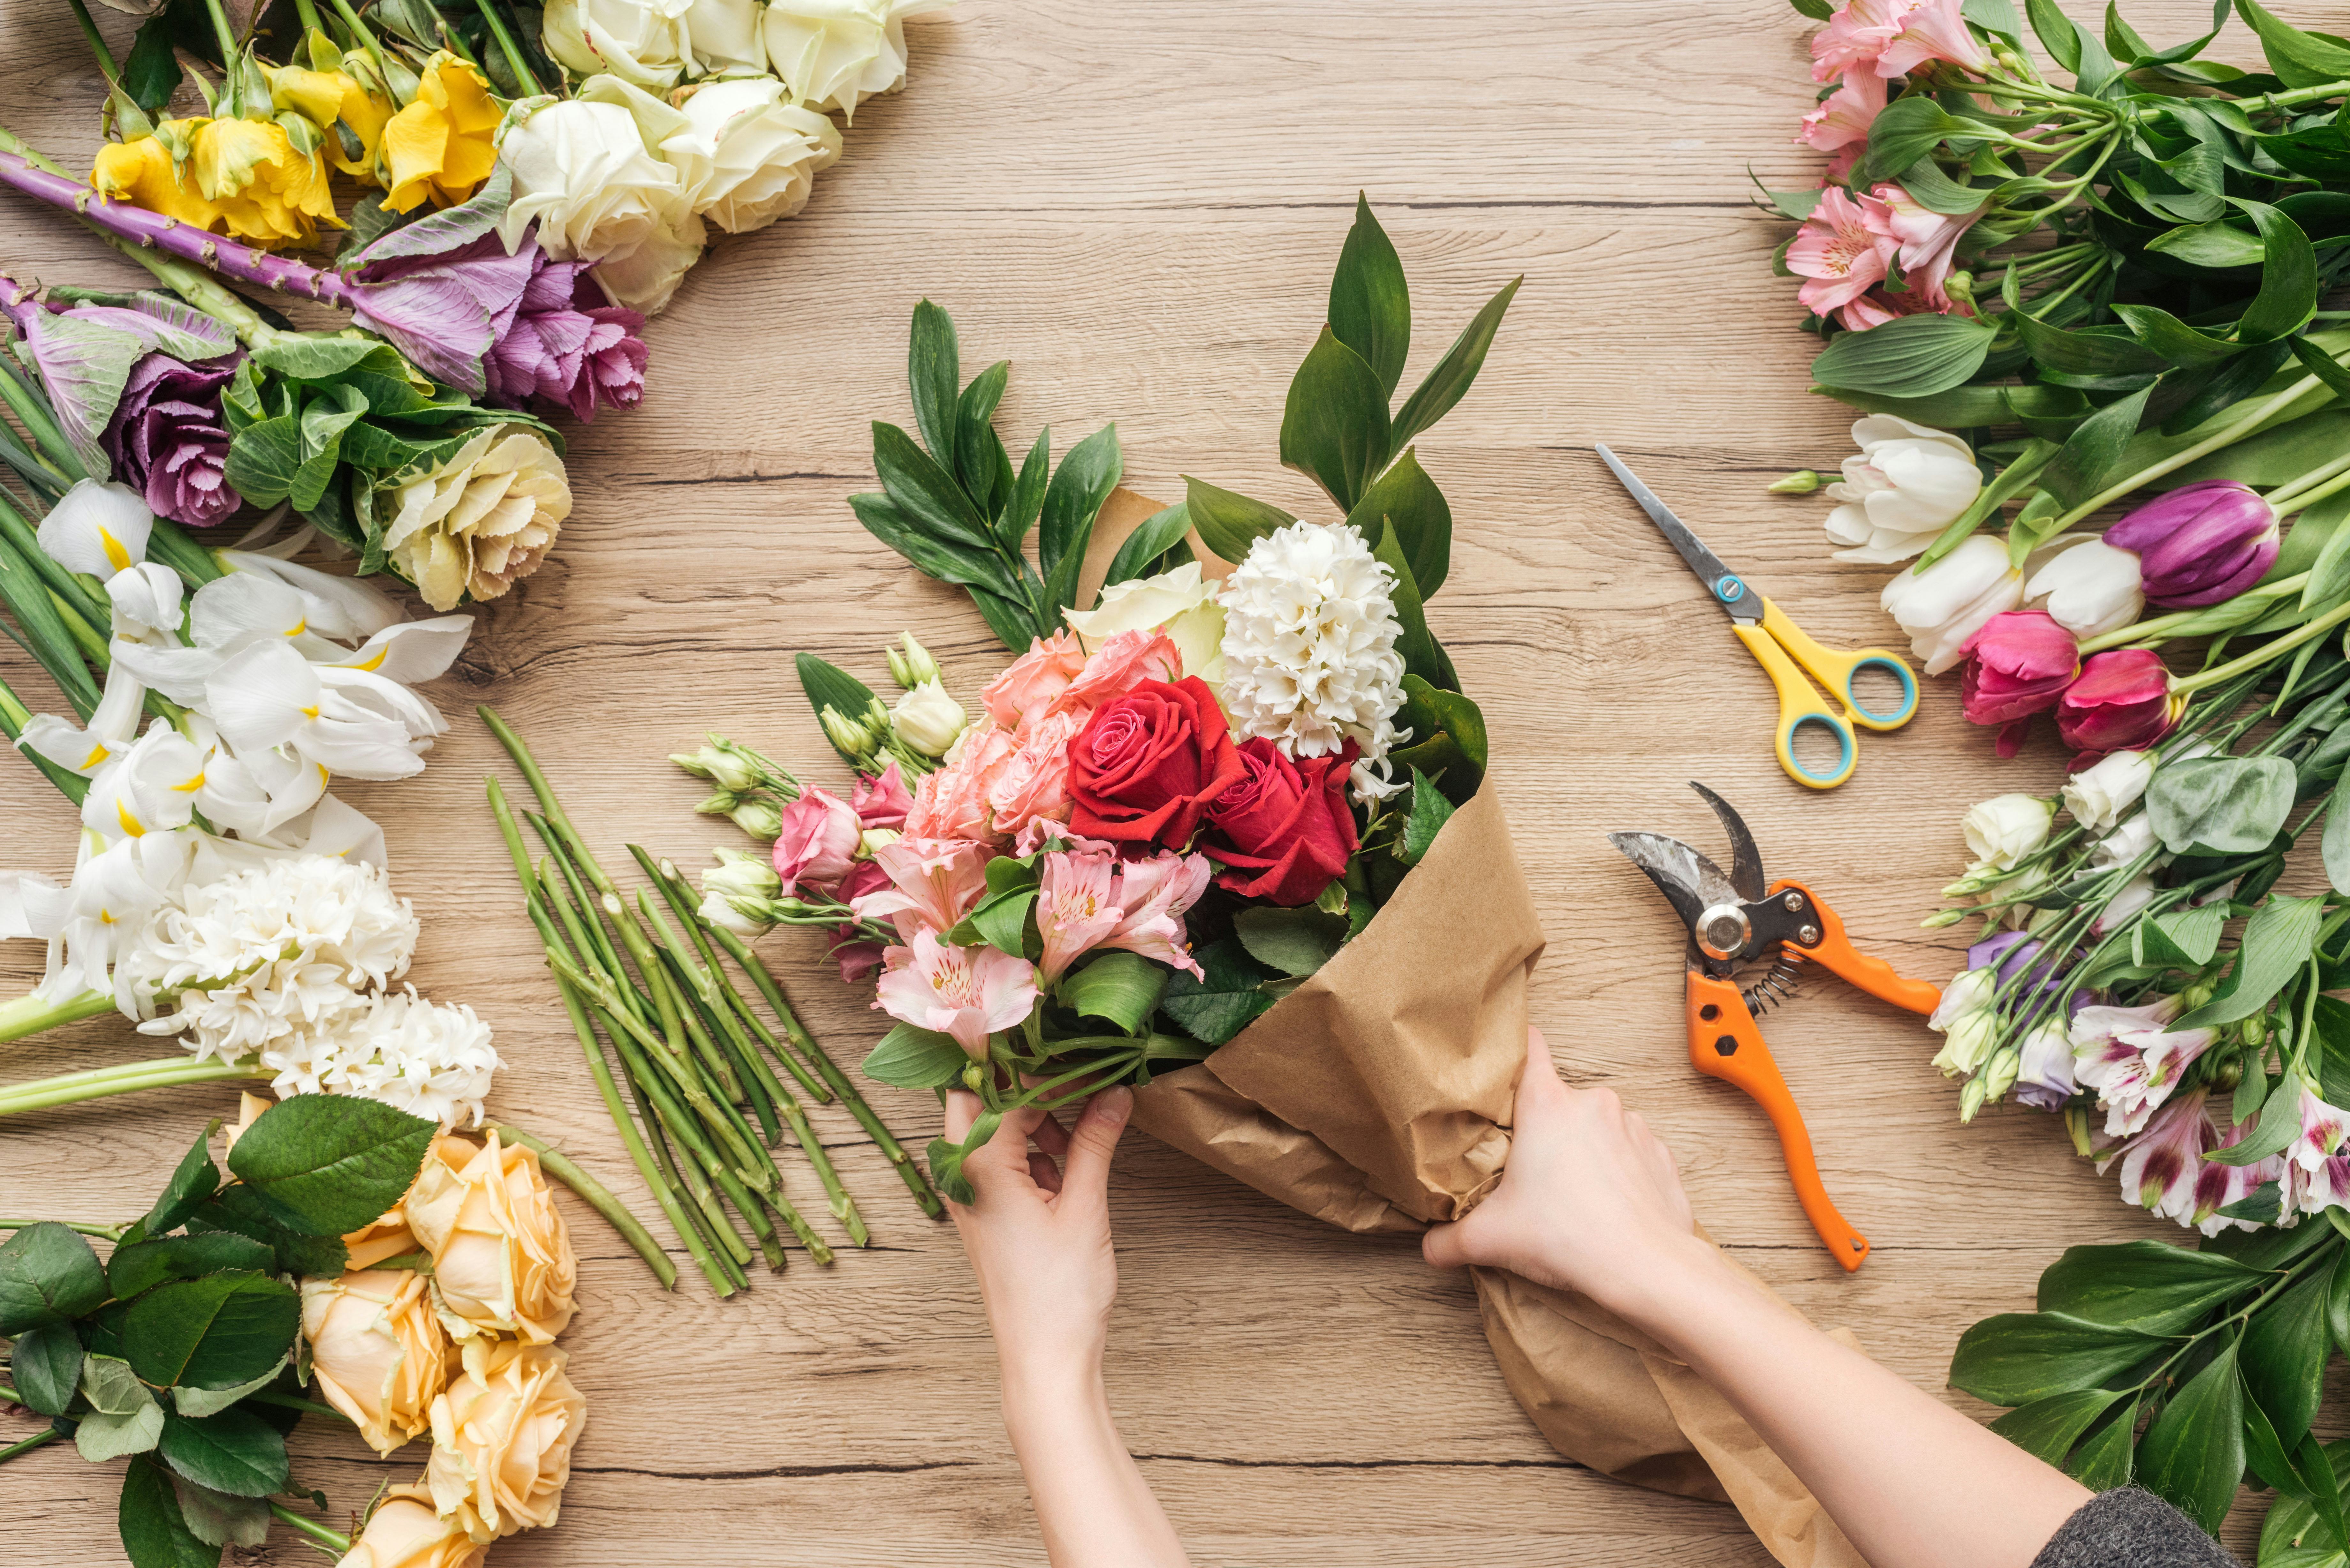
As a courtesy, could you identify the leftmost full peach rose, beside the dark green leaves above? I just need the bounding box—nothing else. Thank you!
[301,1270,451,1453]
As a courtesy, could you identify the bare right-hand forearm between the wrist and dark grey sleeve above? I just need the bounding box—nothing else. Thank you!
[1619,1237,2089,1568]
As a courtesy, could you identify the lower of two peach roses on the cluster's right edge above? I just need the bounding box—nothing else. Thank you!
[425,1340,588,1542]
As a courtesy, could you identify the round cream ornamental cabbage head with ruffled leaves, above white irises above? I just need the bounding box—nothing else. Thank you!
[376,426,571,609]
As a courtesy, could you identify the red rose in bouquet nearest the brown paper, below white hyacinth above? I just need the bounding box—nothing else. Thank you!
[1201,738,1356,905]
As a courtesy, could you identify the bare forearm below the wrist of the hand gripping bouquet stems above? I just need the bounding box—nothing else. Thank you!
[1004,1366,1192,1568]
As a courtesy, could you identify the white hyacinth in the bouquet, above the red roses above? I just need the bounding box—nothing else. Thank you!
[1217,522,1408,799]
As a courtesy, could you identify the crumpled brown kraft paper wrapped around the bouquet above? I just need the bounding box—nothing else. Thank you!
[1135,788,1863,1568]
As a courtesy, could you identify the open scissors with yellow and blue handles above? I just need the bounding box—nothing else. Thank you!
[1596,447,1918,790]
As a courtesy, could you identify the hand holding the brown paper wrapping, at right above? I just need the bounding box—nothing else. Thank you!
[1422,1030,1716,1316]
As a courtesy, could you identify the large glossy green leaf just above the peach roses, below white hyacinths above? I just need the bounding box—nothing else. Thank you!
[224,1096,439,1241]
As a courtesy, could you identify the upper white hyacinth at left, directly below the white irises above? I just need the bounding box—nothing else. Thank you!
[118,856,416,1067]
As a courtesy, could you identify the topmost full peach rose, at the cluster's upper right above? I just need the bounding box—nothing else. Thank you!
[402,1128,578,1345]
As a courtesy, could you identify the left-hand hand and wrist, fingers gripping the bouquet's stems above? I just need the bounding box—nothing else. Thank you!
[947,1089,1135,1401]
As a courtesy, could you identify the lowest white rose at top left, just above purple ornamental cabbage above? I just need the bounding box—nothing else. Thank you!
[498,94,691,261]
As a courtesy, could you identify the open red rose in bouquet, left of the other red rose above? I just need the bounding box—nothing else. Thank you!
[1069,677,1241,849]
